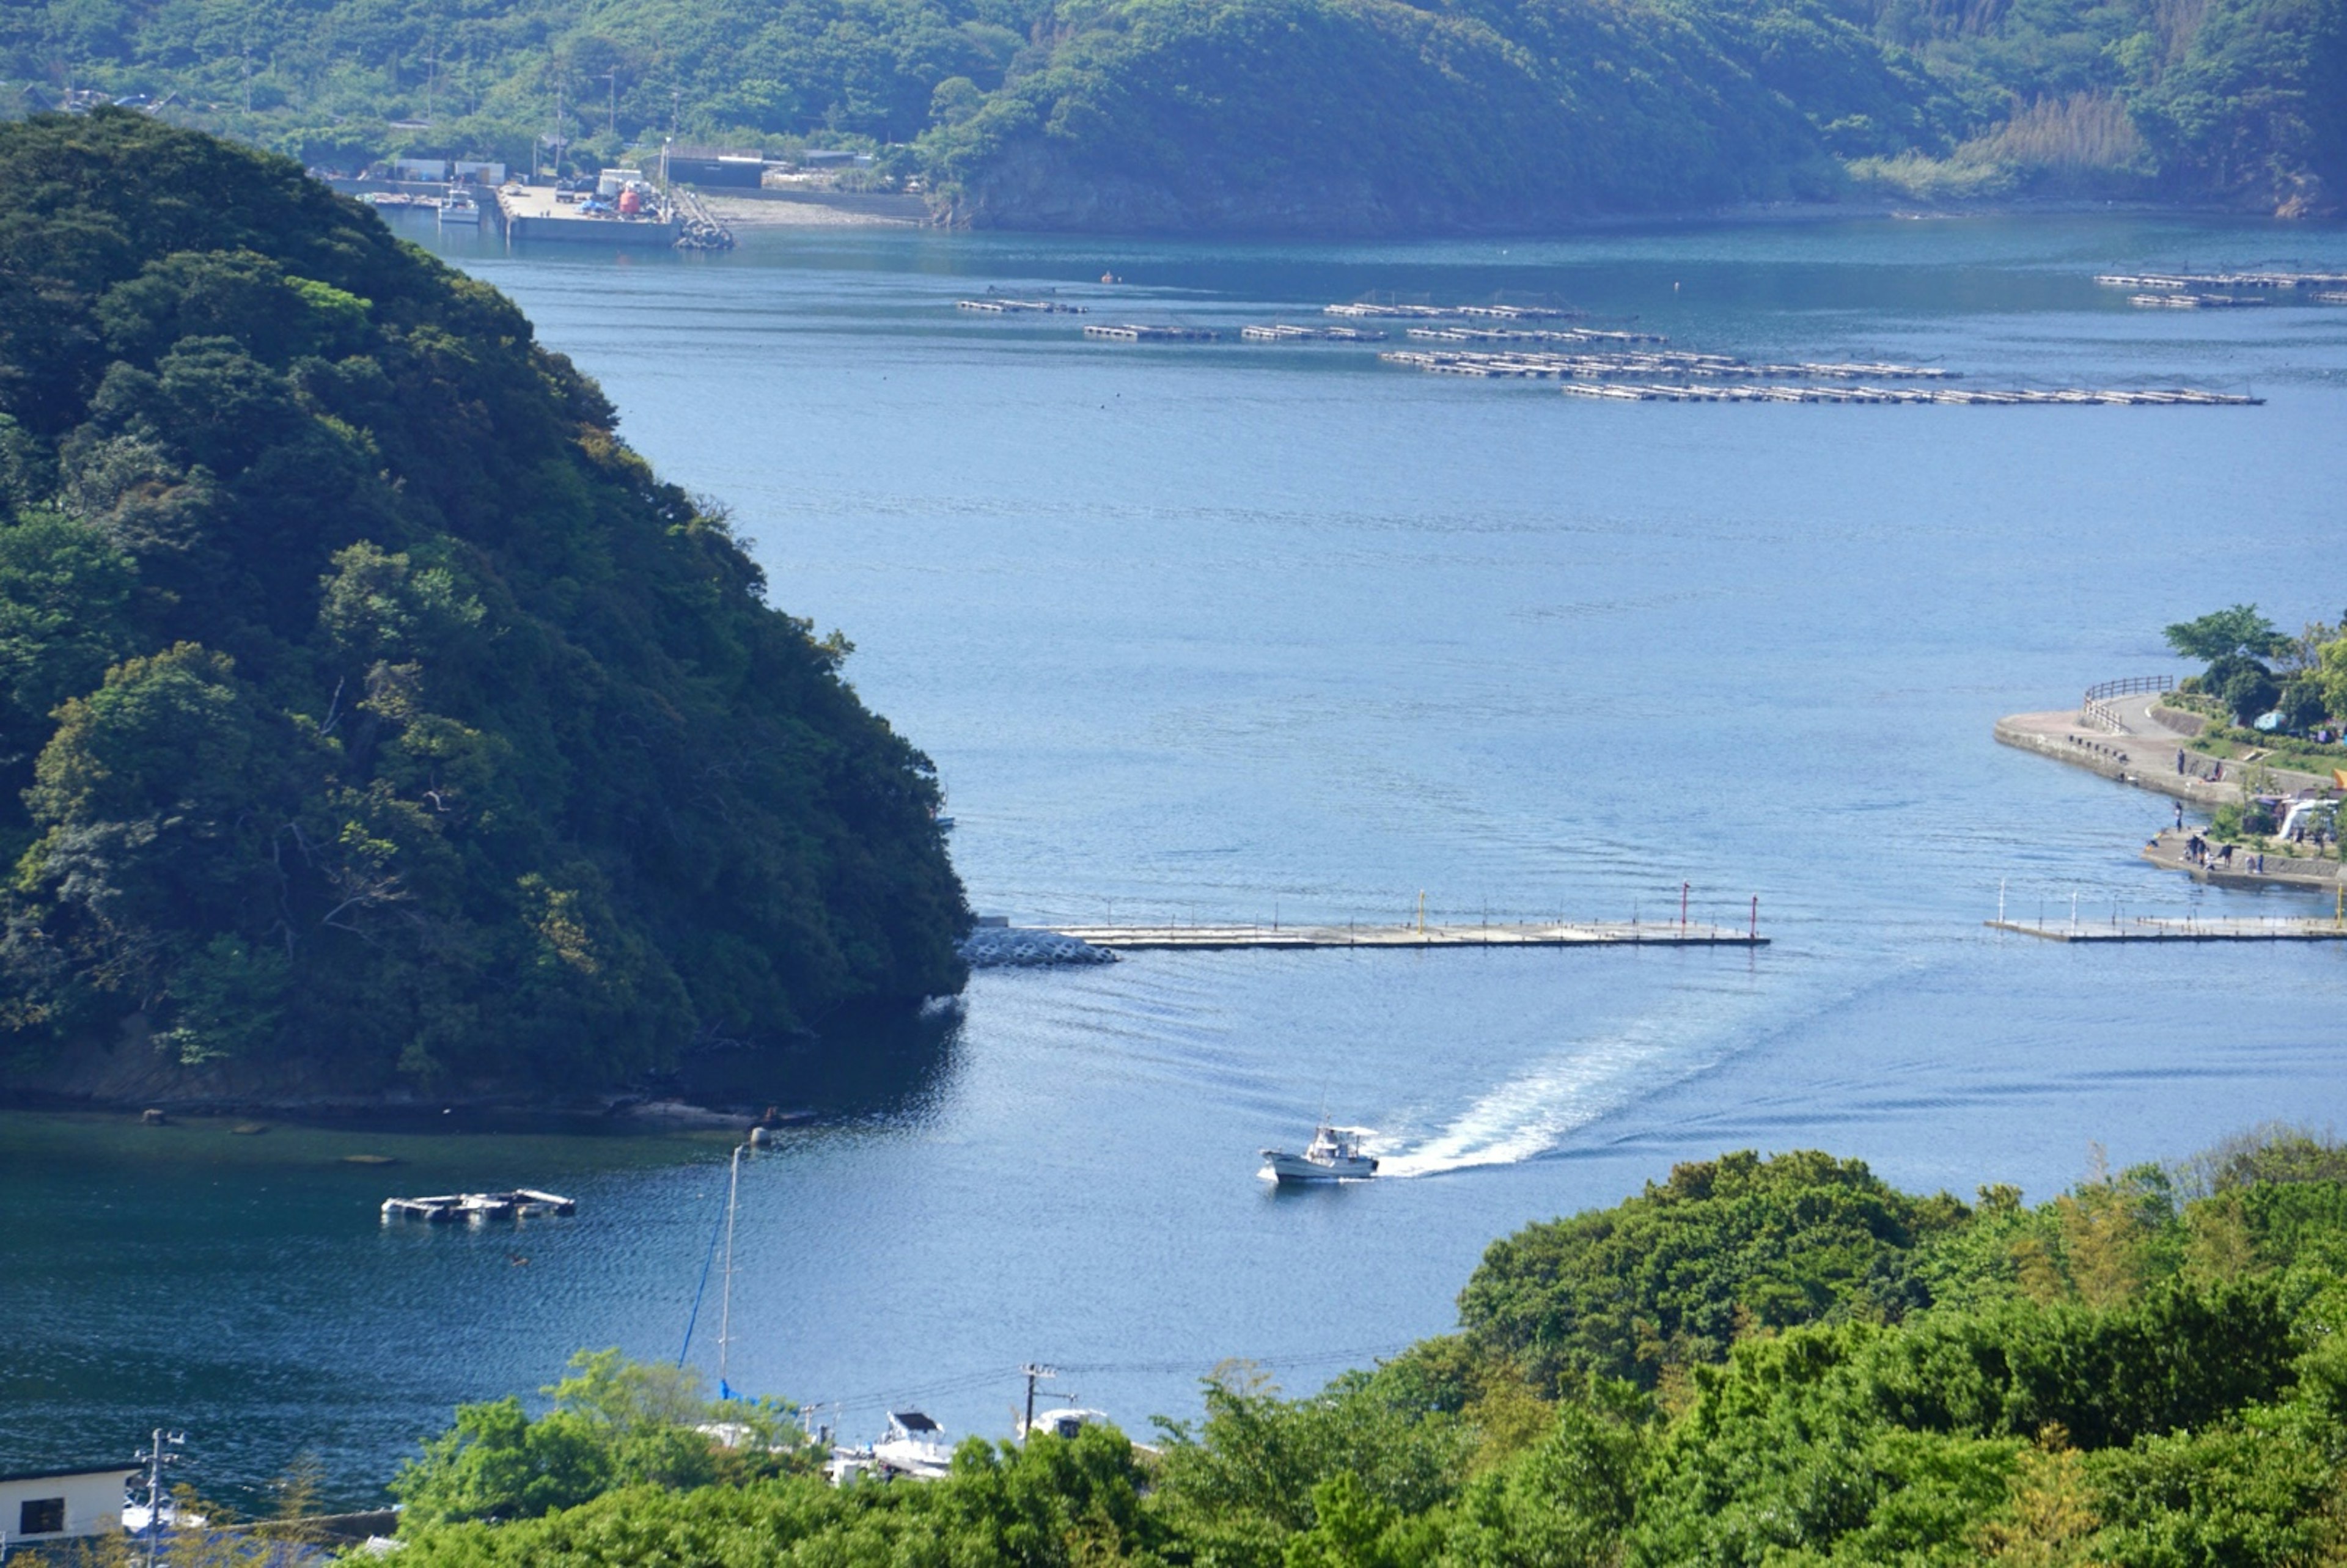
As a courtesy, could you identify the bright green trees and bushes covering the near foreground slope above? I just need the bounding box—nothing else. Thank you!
[238,1132,2347,1568]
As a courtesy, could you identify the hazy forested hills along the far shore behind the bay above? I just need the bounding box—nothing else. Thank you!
[0,0,2347,235]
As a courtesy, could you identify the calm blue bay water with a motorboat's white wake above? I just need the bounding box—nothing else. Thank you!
[0,216,2347,1502]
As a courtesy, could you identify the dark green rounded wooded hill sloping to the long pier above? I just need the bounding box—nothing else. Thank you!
[0,111,967,1091]
